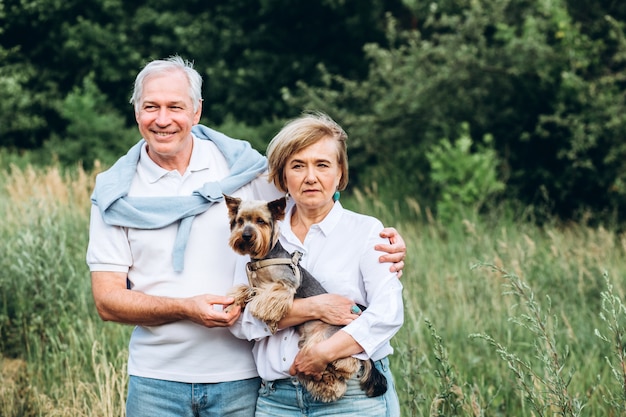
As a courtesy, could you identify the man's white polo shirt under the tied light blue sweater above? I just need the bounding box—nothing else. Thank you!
[87,137,281,383]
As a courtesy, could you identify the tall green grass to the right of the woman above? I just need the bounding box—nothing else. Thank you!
[348,189,626,416]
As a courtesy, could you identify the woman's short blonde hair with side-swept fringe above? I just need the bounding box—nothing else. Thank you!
[266,112,348,192]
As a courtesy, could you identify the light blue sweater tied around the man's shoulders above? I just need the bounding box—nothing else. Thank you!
[91,125,267,272]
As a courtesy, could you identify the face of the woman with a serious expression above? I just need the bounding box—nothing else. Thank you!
[285,138,341,210]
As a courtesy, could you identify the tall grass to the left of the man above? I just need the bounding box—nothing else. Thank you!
[0,165,129,416]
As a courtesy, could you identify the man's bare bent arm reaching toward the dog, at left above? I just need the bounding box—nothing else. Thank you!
[91,272,241,327]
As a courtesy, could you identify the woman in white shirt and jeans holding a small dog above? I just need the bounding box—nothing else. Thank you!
[235,113,403,417]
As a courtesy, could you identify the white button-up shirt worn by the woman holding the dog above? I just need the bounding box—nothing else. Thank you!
[231,201,404,381]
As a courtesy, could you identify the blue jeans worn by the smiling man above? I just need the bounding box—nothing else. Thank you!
[126,375,261,417]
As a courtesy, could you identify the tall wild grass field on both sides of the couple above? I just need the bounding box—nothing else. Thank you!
[0,166,626,417]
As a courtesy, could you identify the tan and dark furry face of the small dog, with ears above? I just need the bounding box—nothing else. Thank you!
[224,195,287,259]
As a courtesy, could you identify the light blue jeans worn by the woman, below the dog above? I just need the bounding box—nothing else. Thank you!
[255,358,400,417]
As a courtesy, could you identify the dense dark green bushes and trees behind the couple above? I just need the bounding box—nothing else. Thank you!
[0,0,626,223]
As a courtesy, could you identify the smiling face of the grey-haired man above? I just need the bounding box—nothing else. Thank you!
[135,71,202,169]
